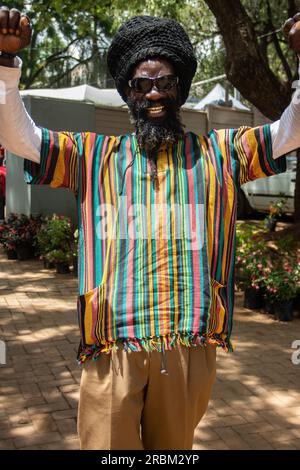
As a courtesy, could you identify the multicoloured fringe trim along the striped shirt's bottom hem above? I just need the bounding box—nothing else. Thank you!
[77,333,234,364]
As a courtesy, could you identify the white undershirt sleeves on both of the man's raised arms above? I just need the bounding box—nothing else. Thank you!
[0,58,300,163]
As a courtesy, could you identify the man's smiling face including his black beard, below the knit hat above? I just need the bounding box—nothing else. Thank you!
[127,58,184,152]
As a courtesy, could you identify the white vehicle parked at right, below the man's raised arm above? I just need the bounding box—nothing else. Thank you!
[238,153,297,218]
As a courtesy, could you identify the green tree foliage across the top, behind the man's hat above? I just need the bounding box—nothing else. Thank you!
[6,0,296,104]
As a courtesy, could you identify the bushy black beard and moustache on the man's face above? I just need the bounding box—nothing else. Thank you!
[127,97,184,160]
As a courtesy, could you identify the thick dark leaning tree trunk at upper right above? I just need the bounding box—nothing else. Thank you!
[205,0,291,120]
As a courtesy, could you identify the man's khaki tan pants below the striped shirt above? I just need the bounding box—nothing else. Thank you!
[78,345,216,450]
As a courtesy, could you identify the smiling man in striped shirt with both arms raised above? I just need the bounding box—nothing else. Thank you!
[0,7,300,449]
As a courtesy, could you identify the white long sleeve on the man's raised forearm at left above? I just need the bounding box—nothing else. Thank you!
[0,57,41,163]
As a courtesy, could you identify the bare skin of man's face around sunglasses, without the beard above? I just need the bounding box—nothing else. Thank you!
[129,58,178,121]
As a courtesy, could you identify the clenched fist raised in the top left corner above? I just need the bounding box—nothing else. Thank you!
[0,7,31,54]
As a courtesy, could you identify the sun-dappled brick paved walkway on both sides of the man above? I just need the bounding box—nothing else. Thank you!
[0,253,300,449]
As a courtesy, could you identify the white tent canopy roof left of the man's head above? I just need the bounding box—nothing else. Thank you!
[21,85,126,107]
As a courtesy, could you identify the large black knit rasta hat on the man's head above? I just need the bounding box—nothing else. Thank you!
[107,16,197,104]
